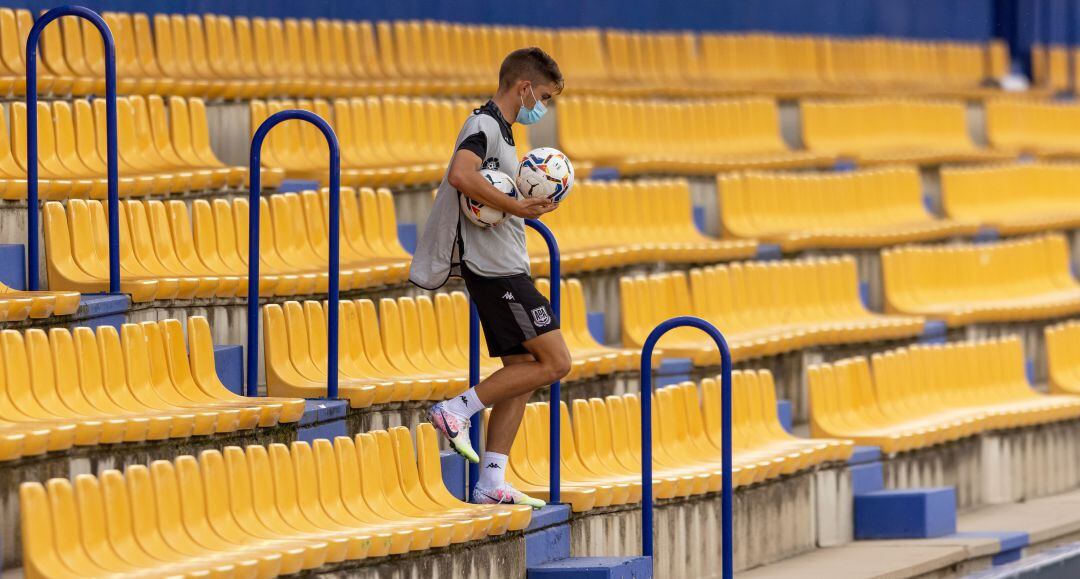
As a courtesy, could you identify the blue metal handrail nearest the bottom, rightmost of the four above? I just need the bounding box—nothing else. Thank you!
[642,315,734,579]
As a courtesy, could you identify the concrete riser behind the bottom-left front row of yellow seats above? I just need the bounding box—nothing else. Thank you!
[0,425,298,569]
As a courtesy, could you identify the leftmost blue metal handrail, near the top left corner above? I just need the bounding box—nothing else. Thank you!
[26,5,120,294]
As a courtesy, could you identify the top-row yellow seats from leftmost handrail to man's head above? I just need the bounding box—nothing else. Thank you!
[108,13,561,98]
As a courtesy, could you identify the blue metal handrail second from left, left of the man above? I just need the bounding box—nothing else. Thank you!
[247,109,341,399]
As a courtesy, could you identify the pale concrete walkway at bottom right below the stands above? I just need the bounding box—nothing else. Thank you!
[738,490,1080,579]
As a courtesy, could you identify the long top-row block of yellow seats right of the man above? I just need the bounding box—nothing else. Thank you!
[696,32,1009,94]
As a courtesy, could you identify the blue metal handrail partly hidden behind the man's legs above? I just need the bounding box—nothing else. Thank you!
[469,219,563,503]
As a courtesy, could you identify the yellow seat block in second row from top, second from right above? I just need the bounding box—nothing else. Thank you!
[799,98,1015,164]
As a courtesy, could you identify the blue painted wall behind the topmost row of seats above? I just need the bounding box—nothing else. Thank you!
[0,0,993,40]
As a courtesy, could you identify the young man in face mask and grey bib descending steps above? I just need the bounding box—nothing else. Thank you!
[409,48,570,508]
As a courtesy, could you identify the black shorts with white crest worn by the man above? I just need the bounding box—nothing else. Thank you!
[461,264,558,358]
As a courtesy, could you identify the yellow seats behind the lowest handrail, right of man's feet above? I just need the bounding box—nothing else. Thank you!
[507,371,853,511]
